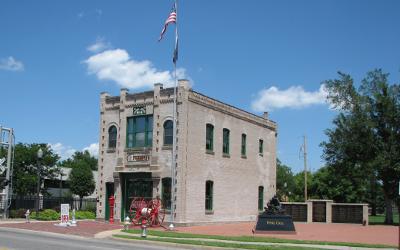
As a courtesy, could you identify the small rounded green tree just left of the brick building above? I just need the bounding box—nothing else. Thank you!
[69,160,95,208]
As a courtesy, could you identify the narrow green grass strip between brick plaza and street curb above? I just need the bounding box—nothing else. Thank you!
[118,229,394,249]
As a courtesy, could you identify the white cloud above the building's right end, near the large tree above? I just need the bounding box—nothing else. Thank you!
[251,85,327,112]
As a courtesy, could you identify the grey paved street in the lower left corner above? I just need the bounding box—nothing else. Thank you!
[0,228,184,250]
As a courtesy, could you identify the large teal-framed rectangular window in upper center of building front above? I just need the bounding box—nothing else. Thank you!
[126,115,153,148]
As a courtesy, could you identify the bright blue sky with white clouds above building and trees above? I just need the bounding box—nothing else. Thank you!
[0,0,400,172]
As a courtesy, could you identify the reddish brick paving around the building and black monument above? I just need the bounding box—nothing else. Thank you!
[0,220,399,249]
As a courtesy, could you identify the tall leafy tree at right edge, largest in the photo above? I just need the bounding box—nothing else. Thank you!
[322,69,400,224]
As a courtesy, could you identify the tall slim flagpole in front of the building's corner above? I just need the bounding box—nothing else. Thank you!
[169,0,178,230]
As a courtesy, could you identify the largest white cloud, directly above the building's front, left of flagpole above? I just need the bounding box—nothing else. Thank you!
[84,49,187,89]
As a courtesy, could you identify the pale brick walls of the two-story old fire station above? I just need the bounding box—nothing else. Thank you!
[97,80,277,224]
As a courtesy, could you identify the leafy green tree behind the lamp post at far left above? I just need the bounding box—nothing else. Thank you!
[0,143,60,195]
